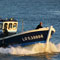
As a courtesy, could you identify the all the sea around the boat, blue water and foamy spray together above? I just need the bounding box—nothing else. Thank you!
[0,0,60,60]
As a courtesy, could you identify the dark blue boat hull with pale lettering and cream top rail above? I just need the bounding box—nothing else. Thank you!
[0,28,53,47]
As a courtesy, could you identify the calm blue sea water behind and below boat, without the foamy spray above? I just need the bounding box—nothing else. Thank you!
[0,0,60,60]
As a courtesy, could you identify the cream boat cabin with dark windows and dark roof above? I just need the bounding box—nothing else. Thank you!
[0,18,18,33]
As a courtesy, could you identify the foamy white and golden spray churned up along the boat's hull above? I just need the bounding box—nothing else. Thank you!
[0,42,60,55]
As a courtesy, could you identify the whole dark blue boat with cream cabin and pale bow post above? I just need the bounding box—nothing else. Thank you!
[0,19,55,47]
